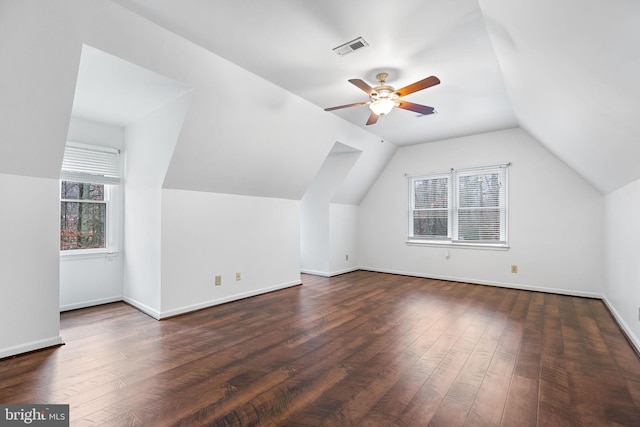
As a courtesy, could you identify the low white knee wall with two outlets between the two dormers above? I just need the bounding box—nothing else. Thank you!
[160,189,301,317]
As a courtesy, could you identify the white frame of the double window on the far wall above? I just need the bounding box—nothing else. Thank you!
[406,163,511,250]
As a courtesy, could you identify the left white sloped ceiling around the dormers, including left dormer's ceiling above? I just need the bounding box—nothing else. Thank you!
[0,0,397,204]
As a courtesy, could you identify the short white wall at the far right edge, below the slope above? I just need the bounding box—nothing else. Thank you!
[605,181,640,351]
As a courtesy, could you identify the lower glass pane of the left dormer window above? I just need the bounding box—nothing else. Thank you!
[60,201,107,250]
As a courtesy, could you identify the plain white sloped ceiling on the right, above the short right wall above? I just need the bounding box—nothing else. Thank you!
[480,0,640,193]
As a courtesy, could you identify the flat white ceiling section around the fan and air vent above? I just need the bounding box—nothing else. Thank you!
[110,0,517,145]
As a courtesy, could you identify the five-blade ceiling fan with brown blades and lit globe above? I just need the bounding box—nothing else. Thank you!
[324,73,440,125]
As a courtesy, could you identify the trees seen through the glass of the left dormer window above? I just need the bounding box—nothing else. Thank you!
[60,181,107,250]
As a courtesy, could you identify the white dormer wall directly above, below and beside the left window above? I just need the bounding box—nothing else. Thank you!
[60,117,124,311]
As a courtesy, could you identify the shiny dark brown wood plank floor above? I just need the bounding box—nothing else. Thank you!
[0,271,640,427]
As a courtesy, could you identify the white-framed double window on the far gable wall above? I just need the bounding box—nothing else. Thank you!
[409,165,507,247]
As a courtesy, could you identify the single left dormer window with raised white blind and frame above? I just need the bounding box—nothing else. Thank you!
[60,143,120,252]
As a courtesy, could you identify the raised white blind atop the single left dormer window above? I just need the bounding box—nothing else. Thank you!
[60,142,120,184]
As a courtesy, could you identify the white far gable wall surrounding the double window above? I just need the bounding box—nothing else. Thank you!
[359,129,604,297]
